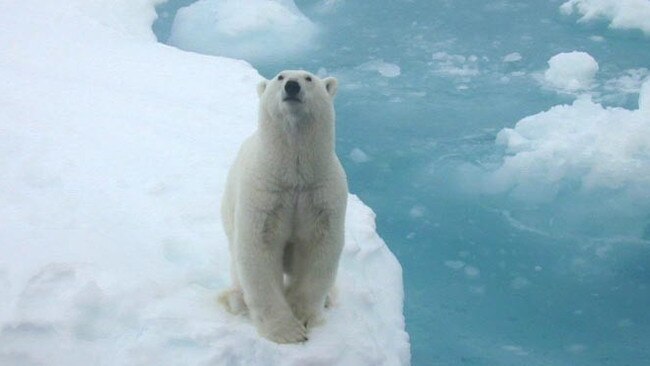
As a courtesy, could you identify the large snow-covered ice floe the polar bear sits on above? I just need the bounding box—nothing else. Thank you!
[0,0,410,365]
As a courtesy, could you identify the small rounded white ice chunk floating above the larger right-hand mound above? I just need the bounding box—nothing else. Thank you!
[544,51,598,92]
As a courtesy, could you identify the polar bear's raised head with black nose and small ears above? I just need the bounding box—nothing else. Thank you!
[257,70,338,122]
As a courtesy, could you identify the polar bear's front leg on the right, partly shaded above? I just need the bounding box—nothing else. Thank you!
[287,213,344,328]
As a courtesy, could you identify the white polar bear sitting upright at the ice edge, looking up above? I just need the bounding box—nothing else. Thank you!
[220,70,348,343]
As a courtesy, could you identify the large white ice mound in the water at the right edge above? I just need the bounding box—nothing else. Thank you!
[480,80,650,199]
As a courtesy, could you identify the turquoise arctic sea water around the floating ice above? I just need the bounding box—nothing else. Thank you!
[154,0,650,366]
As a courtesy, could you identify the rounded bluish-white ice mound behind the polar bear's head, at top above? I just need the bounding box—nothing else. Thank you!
[168,0,317,61]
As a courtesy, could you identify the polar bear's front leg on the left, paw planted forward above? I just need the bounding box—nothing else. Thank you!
[234,209,307,343]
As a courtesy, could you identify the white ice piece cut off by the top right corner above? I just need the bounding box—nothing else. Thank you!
[560,0,650,35]
